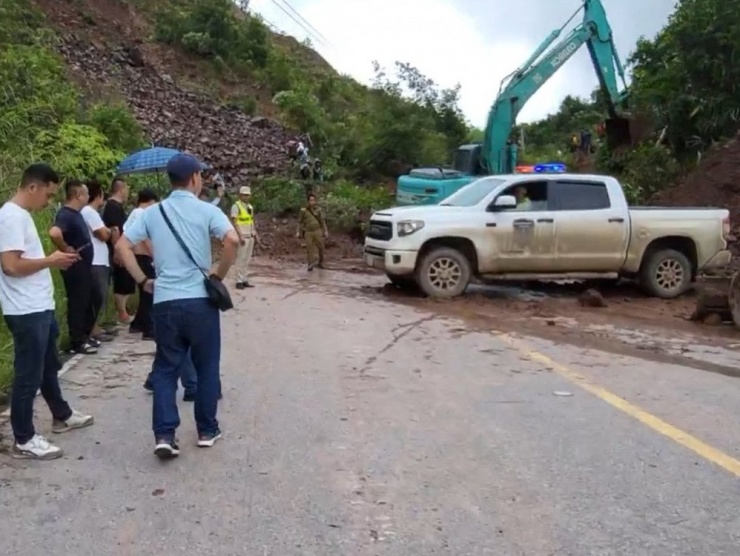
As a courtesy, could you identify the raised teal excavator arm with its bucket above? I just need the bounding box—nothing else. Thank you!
[481,0,629,174]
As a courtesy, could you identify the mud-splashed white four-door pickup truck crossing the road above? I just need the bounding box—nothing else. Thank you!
[364,174,730,298]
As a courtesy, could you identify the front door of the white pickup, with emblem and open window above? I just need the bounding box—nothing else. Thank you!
[480,181,555,274]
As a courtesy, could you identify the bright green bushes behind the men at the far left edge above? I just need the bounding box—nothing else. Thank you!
[0,0,142,391]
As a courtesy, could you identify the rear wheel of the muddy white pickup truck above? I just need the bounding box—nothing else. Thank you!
[640,249,693,299]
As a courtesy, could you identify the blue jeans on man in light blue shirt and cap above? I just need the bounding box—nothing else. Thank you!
[151,299,221,440]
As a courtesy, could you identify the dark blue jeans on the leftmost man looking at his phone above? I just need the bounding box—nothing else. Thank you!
[5,311,72,444]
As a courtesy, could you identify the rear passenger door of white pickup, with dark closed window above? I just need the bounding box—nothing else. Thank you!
[548,179,630,272]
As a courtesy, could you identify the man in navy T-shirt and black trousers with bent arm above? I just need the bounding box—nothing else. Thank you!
[49,180,100,354]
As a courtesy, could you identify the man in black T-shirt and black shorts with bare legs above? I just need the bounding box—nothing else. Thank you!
[103,177,138,326]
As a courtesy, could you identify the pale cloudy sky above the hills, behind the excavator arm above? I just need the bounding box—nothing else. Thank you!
[250,0,676,127]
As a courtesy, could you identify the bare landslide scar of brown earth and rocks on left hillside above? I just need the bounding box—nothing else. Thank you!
[29,0,300,185]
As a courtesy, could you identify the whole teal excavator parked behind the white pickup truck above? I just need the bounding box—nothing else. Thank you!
[396,0,631,205]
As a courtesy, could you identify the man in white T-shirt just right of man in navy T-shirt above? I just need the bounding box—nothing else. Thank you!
[80,180,113,342]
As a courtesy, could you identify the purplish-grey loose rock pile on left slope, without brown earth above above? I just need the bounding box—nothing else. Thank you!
[60,34,289,187]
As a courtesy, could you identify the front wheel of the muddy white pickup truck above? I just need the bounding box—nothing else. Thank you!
[416,247,470,299]
